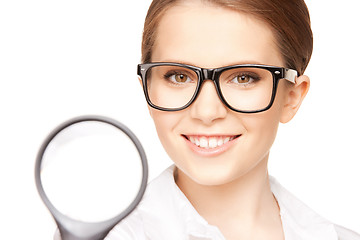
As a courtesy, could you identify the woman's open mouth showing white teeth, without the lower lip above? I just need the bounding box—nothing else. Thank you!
[182,135,241,149]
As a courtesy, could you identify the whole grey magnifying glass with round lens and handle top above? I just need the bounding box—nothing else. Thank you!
[35,116,148,240]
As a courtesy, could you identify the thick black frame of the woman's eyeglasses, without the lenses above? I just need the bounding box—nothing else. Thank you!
[137,62,298,113]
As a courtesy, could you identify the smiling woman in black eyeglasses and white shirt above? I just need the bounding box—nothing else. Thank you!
[107,0,360,240]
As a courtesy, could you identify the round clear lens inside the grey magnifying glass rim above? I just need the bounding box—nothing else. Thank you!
[41,121,142,222]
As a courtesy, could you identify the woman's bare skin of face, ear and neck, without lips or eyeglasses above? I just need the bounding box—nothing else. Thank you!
[145,1,310,240]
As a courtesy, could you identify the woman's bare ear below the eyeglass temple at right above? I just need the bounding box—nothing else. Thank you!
[280,75,310,123]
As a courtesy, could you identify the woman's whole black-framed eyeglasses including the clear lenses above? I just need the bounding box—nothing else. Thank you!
[138,62,298,113]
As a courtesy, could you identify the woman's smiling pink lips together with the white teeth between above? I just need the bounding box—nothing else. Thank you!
[183,135,241,156]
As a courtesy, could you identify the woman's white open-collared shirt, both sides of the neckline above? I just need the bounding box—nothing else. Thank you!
[105,166,360,240]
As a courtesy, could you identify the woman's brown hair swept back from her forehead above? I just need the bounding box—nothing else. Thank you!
[142,0,313,75]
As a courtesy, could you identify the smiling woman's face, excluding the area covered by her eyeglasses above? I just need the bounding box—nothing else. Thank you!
[149,1,296,185]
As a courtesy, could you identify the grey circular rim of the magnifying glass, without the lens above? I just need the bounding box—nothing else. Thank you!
[35,115,148,239]
